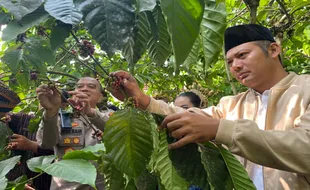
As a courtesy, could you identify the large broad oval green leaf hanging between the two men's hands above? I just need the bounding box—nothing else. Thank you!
[104,108,155,177]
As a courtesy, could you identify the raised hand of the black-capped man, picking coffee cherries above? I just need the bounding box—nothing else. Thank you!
[109,71,150,109]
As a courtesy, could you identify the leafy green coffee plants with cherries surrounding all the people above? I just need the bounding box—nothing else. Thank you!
[0,0,310,190]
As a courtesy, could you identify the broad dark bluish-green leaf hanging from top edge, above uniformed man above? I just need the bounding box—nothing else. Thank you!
[79,0,135,55]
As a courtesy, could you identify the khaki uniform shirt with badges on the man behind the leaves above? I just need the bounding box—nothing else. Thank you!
[37,110,110,190]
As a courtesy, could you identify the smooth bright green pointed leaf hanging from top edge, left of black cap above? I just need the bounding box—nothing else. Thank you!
[161,0,204,69]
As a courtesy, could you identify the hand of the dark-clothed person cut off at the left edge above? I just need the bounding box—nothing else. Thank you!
[7,134,39,153]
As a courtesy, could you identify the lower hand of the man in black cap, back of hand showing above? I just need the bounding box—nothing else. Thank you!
[160,111,219,149]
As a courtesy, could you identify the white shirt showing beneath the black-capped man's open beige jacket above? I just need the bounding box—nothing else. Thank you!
[250,90,270,190]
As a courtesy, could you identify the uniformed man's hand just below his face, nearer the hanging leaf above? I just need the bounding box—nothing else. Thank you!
[68,90,95,117]
